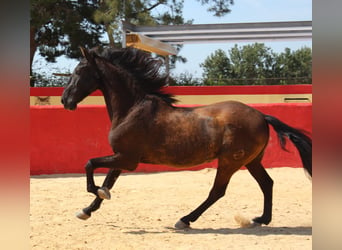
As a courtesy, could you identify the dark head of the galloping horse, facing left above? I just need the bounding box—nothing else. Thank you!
[61,48,101,110]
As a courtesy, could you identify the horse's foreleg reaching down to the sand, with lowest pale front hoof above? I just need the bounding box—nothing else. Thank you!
[76,169,121,220]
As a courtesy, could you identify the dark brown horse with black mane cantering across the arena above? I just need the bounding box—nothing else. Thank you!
[61,47,312,229]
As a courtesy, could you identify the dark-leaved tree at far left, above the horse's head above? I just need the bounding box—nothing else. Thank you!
[30,0,104,85]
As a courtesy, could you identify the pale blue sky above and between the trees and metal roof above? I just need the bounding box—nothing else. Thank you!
[33,0,312,77]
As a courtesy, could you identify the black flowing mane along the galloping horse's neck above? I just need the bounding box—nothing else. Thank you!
[93,47,177,105]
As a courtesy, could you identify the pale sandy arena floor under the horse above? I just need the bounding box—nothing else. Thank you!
[30,168,312,250]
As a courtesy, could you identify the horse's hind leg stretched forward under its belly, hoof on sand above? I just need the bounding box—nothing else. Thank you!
[175,161,240,229]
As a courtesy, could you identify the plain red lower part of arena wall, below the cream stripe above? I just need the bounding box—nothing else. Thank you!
[30,102,312,175]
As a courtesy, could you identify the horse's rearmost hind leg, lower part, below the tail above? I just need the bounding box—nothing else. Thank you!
[246,155,273,225]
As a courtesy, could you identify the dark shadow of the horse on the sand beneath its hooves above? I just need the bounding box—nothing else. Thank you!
[107,223,312,236]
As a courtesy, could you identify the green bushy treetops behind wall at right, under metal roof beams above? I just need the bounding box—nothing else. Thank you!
[200,43,312,85]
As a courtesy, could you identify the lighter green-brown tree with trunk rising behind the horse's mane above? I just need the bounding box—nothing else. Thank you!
[94,0,234,68]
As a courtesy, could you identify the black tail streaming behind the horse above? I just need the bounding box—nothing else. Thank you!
[265,115,312,176]
